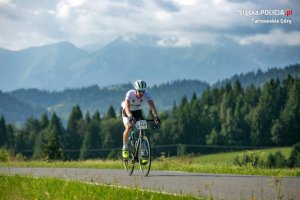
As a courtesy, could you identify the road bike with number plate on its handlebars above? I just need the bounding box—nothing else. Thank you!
[123,120,156,176]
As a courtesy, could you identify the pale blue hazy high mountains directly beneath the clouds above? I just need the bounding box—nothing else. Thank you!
[0,35,300,91]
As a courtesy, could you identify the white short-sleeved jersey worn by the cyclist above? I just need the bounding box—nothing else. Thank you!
[121,90,152,111]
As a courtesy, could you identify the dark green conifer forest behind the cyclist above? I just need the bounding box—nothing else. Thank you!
[0,76,300,160]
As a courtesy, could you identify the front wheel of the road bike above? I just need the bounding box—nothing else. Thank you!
[138,136,151,176]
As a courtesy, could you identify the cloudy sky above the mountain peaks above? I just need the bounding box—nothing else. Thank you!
[0,0,300,50]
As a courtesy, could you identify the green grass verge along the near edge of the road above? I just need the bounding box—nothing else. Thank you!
[0,174,199,200]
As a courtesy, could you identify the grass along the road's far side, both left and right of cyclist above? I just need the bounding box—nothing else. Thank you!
[0,148,300,176]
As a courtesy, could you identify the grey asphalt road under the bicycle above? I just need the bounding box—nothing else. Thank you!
[0,167,300,200]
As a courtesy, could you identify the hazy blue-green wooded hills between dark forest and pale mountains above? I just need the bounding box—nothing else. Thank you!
[0,80,209,124]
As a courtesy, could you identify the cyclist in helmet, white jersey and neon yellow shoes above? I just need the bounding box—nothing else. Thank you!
[122,80,160,164]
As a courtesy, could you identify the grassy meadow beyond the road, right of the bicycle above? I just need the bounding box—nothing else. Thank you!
[153,147,300,176]
